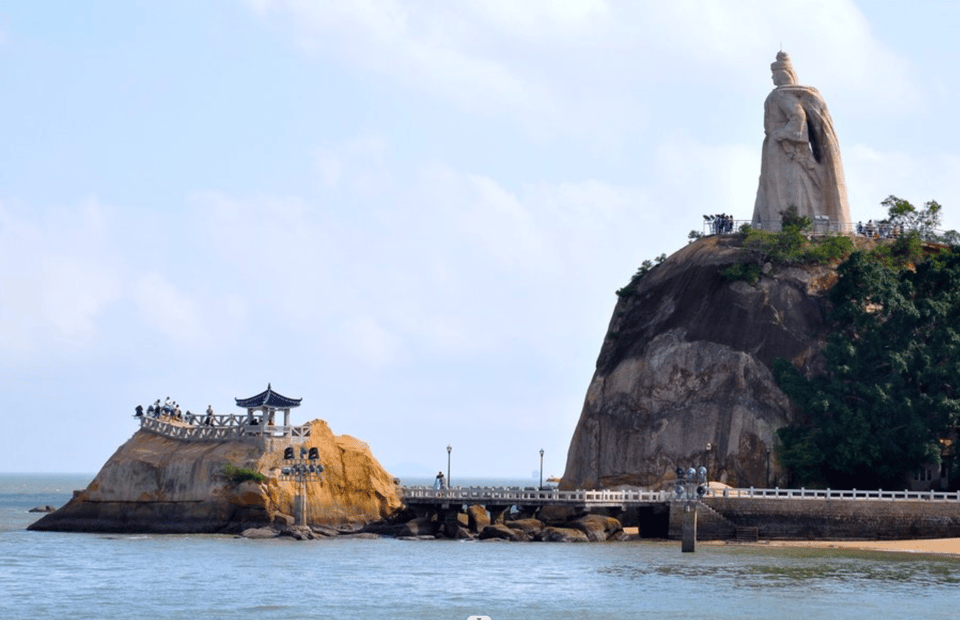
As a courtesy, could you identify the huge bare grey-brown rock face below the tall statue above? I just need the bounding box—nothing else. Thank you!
[561,235,837,489]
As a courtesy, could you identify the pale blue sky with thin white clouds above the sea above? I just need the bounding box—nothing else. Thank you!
[0,0,960,482]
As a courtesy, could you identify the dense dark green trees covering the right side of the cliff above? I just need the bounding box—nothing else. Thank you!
[774,247,960,488]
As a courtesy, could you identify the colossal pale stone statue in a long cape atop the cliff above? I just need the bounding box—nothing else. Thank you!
[753,52,850,231]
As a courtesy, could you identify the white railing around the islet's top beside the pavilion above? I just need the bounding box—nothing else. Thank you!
[140,415,310,441]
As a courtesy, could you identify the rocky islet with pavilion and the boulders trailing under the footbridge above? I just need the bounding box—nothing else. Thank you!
[28,386,636,542]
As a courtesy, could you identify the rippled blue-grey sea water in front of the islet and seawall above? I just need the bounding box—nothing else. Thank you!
[0,474,960,620]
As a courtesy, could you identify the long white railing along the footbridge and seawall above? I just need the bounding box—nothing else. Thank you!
[403,486,960,506]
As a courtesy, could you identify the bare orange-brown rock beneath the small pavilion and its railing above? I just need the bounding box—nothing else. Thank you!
[30,420,400,533]
